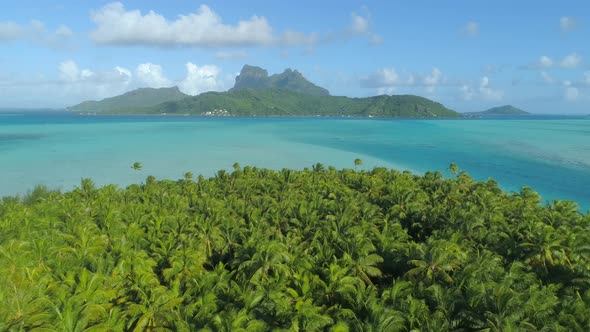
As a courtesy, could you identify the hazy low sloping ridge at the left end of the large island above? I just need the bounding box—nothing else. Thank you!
[67,87,188,113]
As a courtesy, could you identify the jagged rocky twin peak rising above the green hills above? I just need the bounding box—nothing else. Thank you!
[230,65,330,96]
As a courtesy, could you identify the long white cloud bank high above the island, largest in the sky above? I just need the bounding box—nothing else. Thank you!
[91,2,322,47]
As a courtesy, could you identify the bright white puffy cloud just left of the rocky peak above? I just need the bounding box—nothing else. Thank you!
[178,62,223,96]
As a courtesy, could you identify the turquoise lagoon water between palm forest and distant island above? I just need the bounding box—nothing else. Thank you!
[0,112,590,211]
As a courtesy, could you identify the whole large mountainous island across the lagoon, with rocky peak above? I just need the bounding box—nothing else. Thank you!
[68,65,463,118]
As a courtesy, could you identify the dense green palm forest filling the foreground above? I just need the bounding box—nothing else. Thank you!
[0,165,590,331]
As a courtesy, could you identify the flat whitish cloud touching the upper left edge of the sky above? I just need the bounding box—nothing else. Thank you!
[0,20,73,47]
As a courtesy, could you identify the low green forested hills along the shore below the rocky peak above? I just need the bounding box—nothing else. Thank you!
[125,88,462,118]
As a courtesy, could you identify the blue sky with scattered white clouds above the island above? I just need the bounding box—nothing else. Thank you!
[0,0,590,114]
